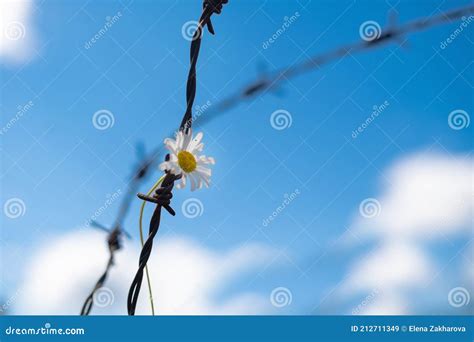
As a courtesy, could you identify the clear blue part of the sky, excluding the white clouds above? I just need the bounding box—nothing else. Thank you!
[0,1,473,313]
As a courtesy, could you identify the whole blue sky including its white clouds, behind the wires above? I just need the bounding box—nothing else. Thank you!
[0,0,474,314]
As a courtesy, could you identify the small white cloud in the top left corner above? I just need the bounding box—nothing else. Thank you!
[0,0,36,63]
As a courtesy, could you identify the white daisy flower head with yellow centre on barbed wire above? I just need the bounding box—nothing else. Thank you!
[160,129,215,191]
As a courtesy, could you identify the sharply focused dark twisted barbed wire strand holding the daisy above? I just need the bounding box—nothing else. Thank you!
[127,0,228,315]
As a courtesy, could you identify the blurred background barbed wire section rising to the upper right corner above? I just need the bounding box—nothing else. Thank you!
[198,5,474,125]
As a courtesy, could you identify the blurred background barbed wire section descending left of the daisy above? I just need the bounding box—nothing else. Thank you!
[81,144,159,316]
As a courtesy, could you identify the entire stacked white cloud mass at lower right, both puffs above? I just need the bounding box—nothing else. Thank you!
[339,153,474,314]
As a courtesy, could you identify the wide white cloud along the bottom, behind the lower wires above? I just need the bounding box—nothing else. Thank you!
[12,230,273,315]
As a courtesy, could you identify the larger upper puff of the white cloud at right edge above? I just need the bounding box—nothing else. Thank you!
[356,153,474,239]
